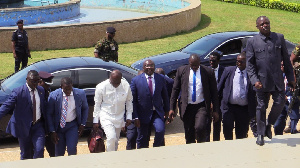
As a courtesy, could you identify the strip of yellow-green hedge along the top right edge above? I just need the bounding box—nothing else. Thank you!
[217,0,300,13]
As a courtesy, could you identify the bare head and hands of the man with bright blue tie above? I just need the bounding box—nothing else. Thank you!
[167,55,219,124]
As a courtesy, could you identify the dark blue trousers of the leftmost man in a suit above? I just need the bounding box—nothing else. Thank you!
[18,122,45,160]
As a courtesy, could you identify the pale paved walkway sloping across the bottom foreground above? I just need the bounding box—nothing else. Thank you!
[0,134,300,168]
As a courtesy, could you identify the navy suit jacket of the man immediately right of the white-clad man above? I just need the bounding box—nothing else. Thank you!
[130,73,170,124]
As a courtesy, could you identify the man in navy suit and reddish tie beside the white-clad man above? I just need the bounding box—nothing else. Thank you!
[130,60,170,148]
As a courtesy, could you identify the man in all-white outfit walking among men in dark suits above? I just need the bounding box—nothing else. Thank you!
[93,70,133,152]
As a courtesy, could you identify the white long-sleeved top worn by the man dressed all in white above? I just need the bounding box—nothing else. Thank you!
[93,79,133,128]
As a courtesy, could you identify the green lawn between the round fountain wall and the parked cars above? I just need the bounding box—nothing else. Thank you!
[0,0,300,78]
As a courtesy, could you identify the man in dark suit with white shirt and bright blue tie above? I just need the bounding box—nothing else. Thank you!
[169,55,219,144]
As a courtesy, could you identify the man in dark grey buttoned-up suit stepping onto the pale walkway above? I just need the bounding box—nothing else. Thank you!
[246,16,295,146]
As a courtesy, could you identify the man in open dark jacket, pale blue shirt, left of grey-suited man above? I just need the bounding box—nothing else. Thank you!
[218,53,256,140]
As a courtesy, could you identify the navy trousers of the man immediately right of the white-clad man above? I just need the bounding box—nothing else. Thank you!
[136,110,165,149]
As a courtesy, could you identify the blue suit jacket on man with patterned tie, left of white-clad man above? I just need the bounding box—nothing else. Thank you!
[47,88,89,132]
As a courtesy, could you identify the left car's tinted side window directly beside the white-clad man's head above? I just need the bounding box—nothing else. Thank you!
[78,69,109,89]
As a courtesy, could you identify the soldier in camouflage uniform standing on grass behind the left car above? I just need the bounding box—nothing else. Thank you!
[94,27,119,62]
